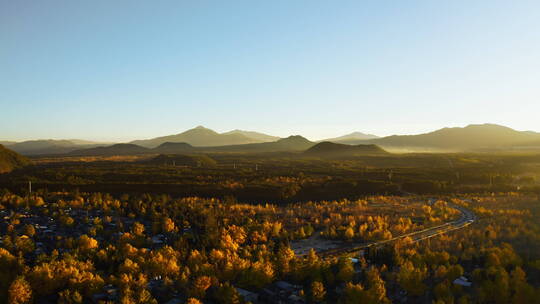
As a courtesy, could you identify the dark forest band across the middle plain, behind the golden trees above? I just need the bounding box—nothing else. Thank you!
[0,156,540,203]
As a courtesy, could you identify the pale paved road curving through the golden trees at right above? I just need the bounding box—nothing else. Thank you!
[293,199,476,257]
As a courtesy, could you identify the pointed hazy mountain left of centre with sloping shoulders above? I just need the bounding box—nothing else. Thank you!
[131,126,261,148]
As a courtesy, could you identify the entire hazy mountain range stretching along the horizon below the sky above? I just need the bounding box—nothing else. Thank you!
[4,124,540,155]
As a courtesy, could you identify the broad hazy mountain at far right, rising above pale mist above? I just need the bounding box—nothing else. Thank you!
[344,124,540,152]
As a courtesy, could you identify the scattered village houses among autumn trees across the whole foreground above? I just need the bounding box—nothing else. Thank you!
[0,200,472,304]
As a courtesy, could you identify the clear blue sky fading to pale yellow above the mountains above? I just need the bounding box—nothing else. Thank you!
[0,0,540,141]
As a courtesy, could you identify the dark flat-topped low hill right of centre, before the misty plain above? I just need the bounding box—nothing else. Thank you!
[304,141,388,157]
